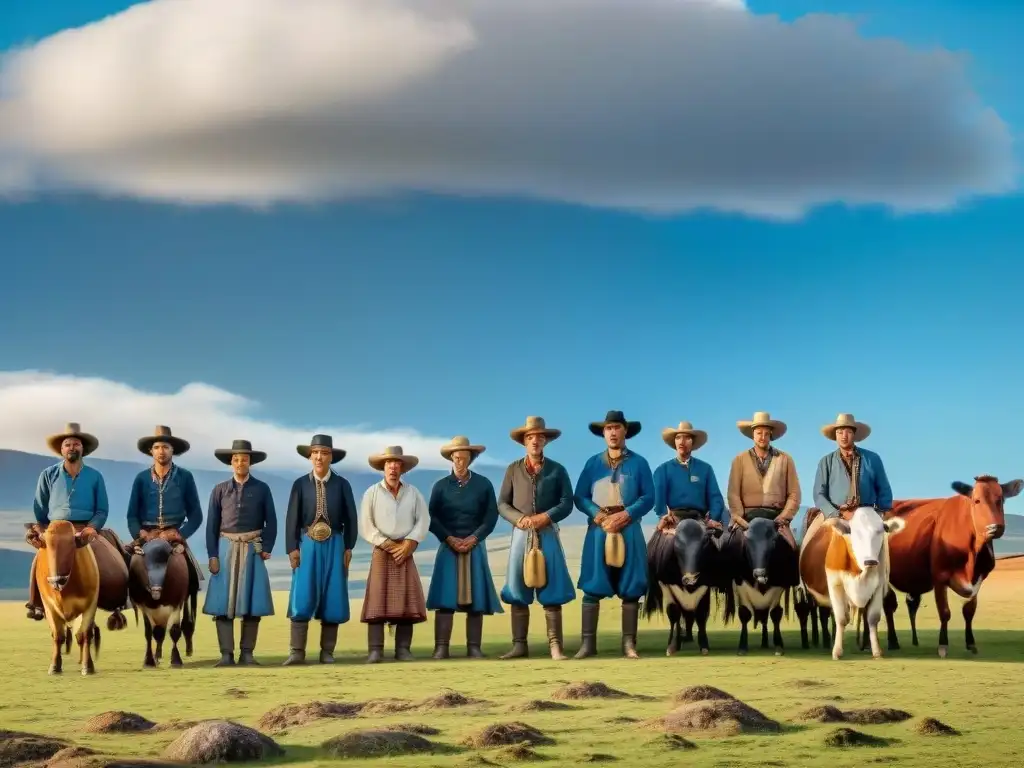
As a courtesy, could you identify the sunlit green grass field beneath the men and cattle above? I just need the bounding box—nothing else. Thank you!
[0,561,1024,768]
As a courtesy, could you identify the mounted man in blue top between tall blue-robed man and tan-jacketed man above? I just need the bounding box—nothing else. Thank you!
[654,421,728,530]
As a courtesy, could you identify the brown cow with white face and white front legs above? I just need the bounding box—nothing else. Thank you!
[800,507,905,659]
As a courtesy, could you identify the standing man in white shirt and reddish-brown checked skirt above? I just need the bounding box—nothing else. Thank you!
[359,445,430,664]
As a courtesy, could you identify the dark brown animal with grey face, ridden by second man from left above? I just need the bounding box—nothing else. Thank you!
[128,530,197,667]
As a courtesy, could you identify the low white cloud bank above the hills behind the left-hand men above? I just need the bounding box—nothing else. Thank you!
[0,371,495,472]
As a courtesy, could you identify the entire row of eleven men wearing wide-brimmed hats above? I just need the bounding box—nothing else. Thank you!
[22,411,892,666]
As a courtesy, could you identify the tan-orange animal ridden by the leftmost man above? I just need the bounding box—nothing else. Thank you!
[35,520,99,675]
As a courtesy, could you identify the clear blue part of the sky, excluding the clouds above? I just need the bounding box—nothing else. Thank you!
[0,1,1024,511]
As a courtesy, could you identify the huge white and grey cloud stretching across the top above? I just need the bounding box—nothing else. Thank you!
[0,0,1016,218]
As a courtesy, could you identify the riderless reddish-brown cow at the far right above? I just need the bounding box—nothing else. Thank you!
[886,475,1024,658]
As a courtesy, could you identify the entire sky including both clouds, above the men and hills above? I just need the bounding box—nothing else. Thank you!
[0,0,1024,512]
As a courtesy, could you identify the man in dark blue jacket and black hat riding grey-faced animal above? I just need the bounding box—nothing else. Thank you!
[127,426,204,624]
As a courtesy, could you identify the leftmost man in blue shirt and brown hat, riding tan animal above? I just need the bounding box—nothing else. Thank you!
[26,423,128,630]
